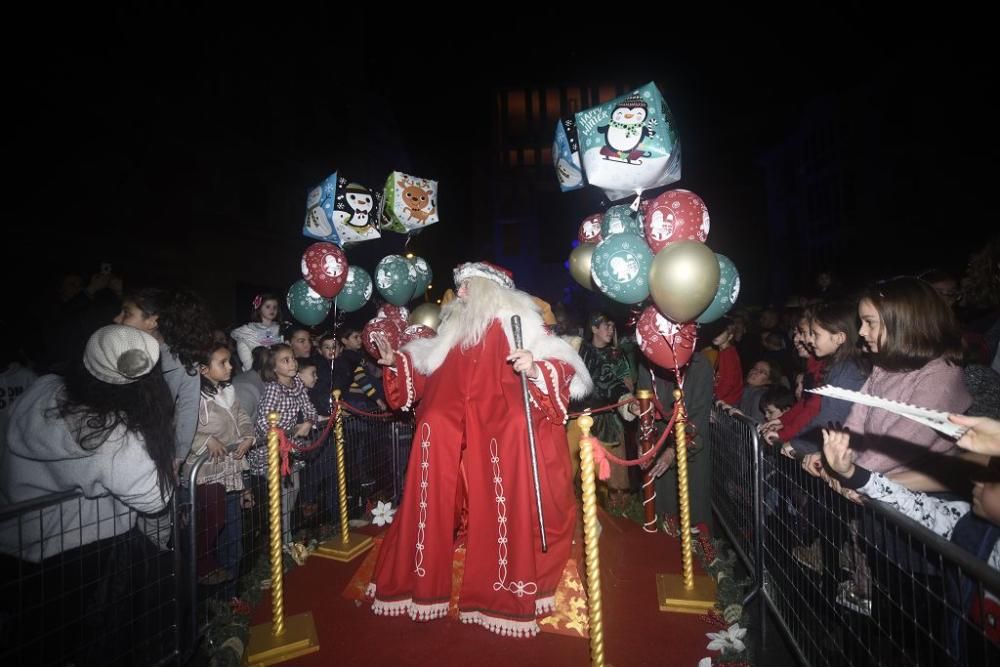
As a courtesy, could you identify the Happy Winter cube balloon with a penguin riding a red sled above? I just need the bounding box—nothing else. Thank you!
[576,83,681,200]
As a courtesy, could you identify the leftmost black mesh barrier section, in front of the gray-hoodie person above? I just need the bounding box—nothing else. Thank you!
[0,492,183,666]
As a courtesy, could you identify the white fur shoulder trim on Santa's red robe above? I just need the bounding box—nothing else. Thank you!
[402,290,594,398]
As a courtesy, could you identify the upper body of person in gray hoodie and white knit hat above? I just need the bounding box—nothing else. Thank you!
[0,325,173,563]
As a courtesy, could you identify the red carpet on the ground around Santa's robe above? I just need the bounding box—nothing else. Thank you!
[253,513,715,667]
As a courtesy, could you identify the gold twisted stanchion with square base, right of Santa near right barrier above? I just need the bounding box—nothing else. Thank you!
[656,389,715,614]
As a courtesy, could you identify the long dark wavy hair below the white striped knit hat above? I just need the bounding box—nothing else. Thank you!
[54,362,175,499]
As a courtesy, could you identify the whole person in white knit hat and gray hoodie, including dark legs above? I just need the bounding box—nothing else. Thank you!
[0,325,174,664]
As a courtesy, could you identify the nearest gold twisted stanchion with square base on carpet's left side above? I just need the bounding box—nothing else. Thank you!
[247,412,319,665]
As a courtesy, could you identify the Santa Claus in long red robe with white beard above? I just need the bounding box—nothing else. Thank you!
[368,262,592,637]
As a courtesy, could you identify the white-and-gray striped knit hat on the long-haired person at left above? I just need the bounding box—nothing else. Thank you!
[83,324,160,384]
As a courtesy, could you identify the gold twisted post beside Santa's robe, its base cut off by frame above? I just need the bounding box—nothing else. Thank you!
[579,414,604,667]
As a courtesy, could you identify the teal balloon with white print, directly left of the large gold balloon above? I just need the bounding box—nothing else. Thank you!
[590,233,653,304]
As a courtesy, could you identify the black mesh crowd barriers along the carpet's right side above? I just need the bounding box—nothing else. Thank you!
[712,408,1000,666]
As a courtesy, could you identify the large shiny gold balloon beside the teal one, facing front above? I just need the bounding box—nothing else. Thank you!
[649,241,719,323]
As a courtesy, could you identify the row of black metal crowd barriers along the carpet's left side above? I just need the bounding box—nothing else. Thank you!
[0,404,413,667]
